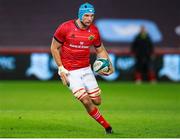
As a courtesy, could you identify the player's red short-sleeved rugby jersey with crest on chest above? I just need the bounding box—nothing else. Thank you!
[54,20,101,70]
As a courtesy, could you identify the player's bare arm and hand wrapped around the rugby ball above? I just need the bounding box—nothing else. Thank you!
[95,43,114,75]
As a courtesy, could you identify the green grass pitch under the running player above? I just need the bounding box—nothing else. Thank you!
[0,81,180,138]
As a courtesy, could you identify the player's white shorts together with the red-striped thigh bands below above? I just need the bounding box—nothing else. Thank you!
[68,66,101,100]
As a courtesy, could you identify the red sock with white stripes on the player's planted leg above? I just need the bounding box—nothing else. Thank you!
[89,107,110,128]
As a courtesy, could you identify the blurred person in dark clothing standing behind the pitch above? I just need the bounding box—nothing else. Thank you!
[131,26,156,83]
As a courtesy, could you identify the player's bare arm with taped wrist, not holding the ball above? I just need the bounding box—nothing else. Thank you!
[51,38,69,85]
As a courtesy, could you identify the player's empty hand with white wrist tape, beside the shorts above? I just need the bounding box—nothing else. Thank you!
[58,66,69,86]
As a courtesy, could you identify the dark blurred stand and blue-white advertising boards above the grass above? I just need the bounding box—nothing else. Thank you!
[0,0,180,81]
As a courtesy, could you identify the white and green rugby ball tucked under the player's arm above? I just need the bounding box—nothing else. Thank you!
[93,58,110,73]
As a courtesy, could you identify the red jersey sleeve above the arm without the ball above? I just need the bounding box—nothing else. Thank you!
[54,24,66,43]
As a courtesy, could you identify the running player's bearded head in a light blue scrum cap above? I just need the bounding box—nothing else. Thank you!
[78,3,95,25]
